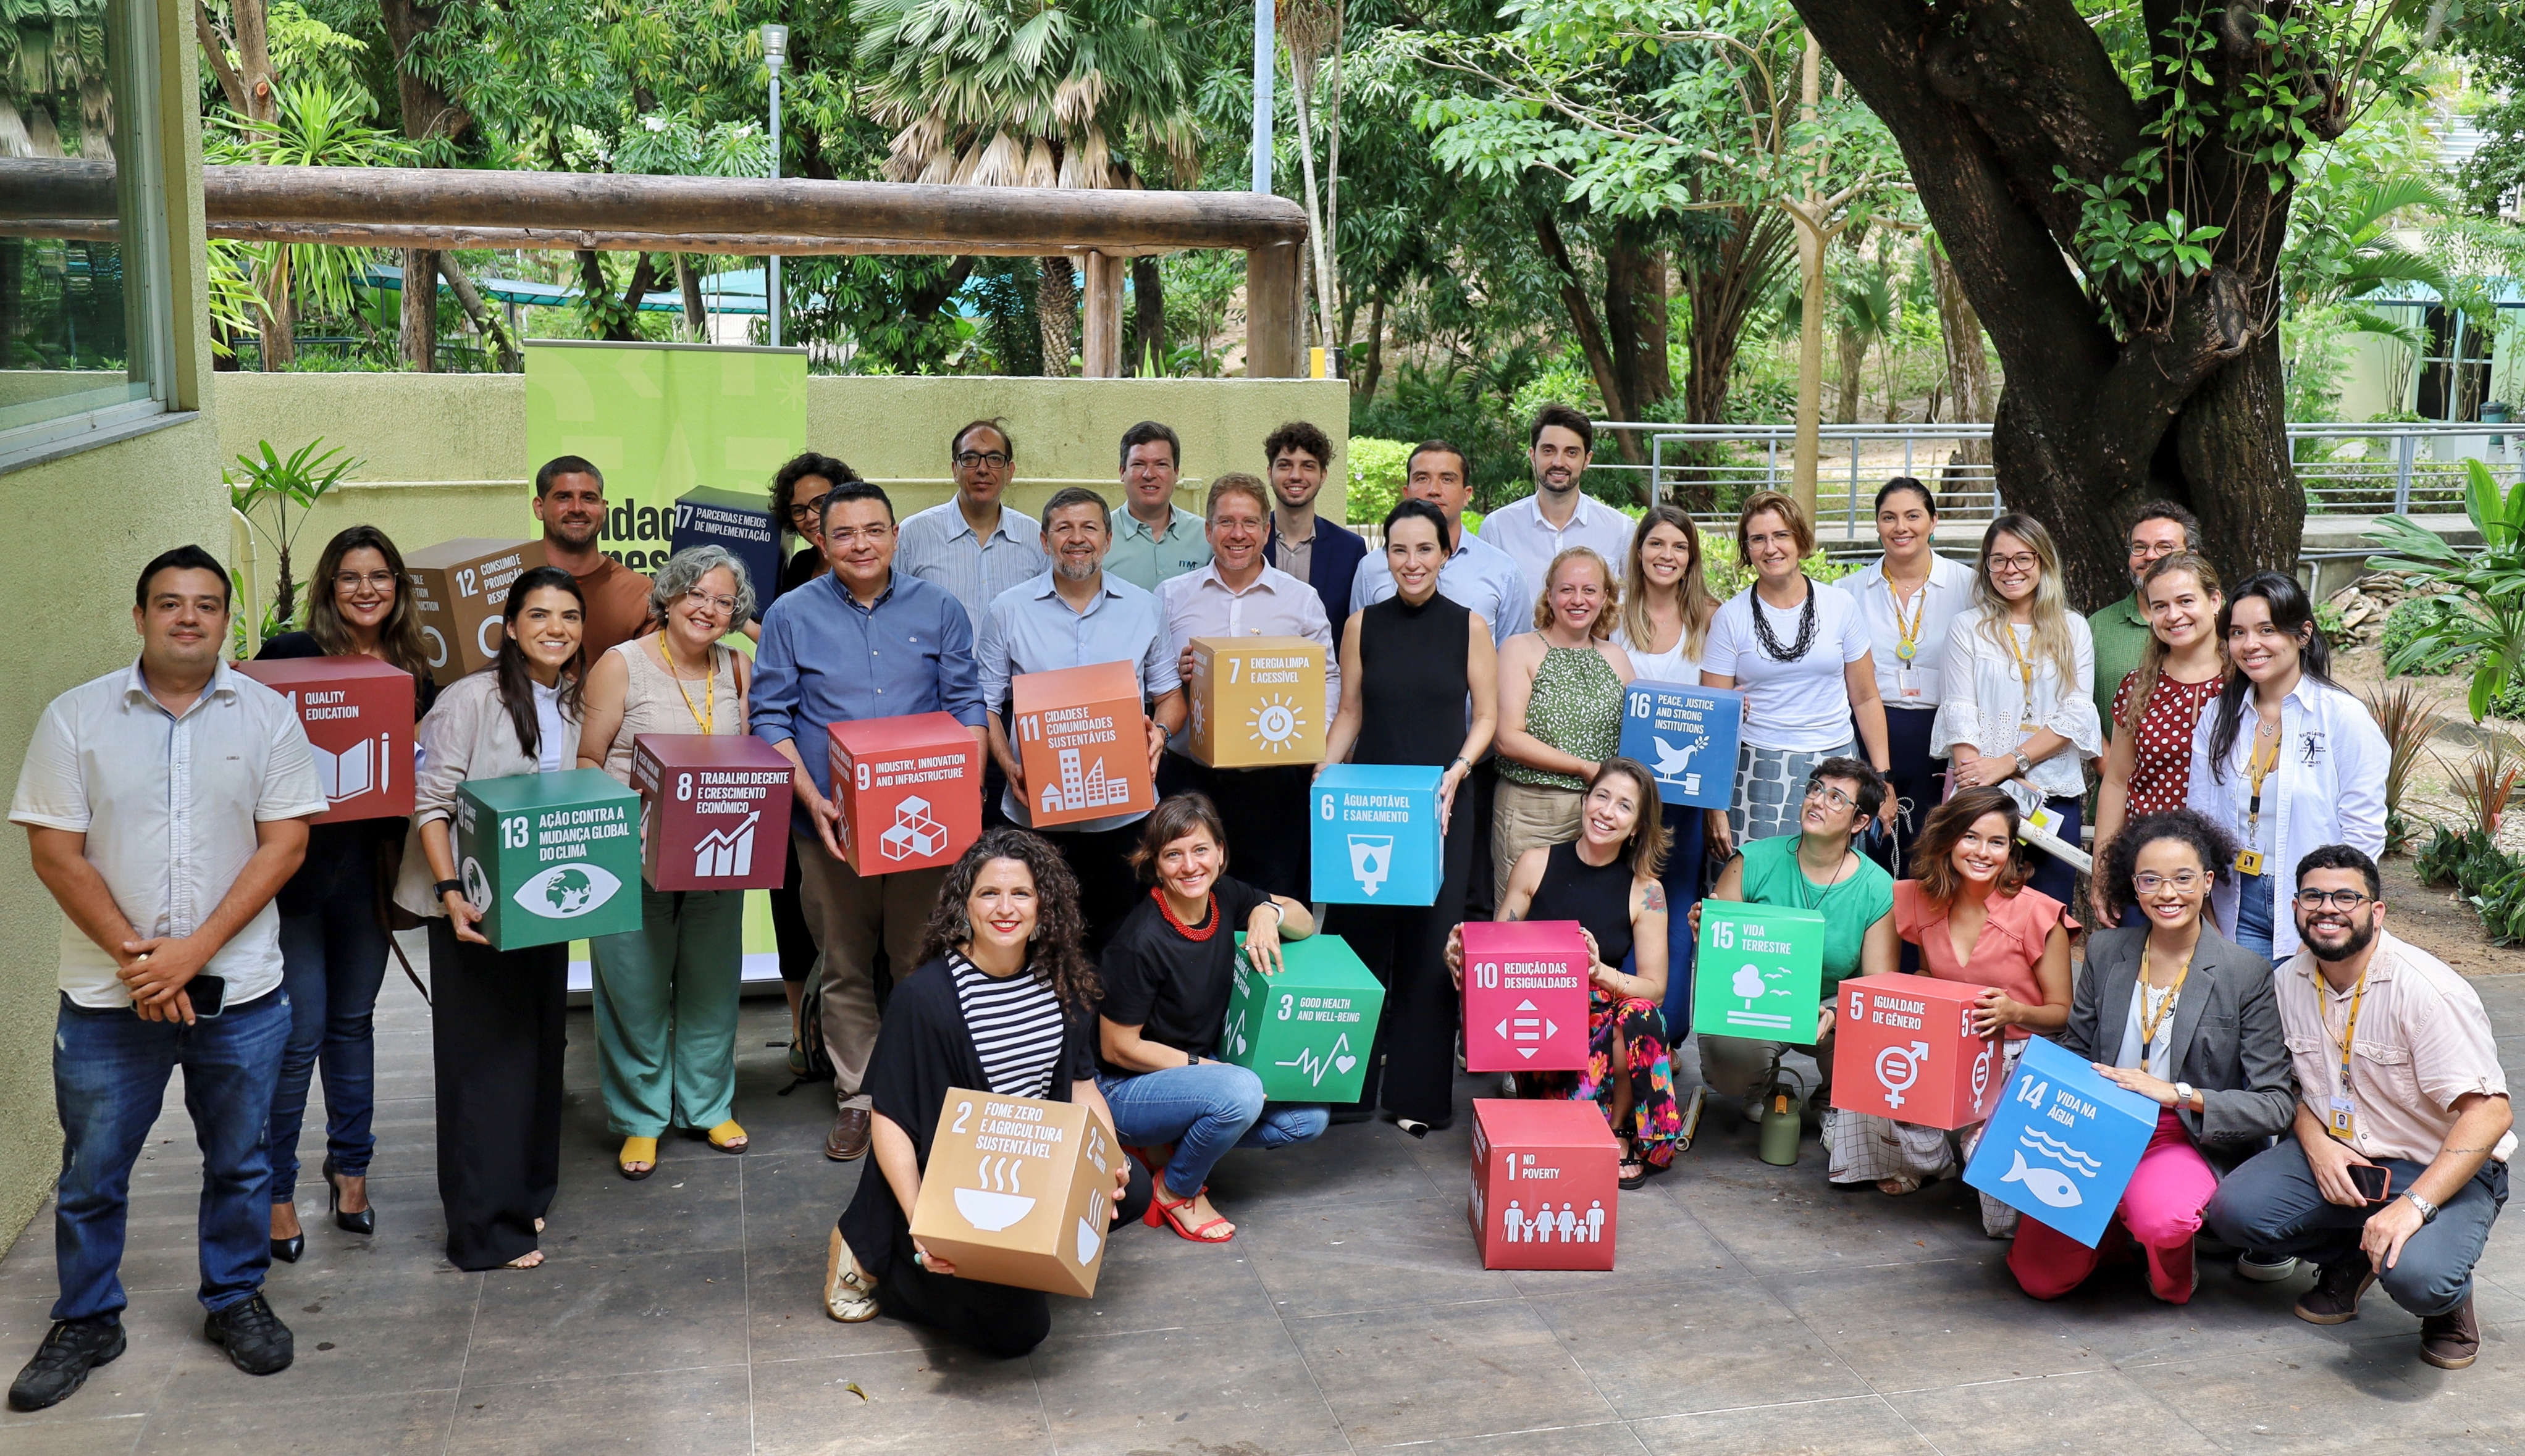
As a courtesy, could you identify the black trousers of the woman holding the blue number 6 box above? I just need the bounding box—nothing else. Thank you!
[1326,777,1487,1123]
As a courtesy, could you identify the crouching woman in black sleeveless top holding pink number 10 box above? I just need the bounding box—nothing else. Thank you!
[1447,757,1684,1189]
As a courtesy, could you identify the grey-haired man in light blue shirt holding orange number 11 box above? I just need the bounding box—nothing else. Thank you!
[975,487,1184,949]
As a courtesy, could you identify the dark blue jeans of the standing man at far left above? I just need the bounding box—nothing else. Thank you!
[53,989,290,1320]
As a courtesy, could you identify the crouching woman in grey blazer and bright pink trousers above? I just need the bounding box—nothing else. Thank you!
[2007,810,2298,1305]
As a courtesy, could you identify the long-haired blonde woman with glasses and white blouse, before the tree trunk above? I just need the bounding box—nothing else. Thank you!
[1929,510,2103,906]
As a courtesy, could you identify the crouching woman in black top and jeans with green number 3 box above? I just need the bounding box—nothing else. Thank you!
[1096,795,1330,1244]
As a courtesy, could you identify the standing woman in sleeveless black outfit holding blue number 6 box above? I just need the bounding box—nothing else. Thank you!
[1323,500,1500,1138]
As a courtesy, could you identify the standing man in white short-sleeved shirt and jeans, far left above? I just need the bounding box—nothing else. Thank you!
[10,545,326,1410]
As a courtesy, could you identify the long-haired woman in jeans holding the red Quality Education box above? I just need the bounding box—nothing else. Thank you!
[255,525,439,1264]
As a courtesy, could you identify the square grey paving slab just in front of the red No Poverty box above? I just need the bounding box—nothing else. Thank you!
[1290,1300,1613,1449]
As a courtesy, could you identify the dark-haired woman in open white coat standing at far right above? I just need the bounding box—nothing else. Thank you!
[2189,571,2391,964]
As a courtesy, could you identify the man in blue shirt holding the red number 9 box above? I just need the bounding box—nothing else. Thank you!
[750,479,987,1161]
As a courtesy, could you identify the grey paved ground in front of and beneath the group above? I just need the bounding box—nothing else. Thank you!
[0,953,2525,1456]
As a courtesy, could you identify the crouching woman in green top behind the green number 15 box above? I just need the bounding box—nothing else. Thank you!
[1692,757,1901,1118]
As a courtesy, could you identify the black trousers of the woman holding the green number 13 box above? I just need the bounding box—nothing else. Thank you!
[429,919,571,1270]
